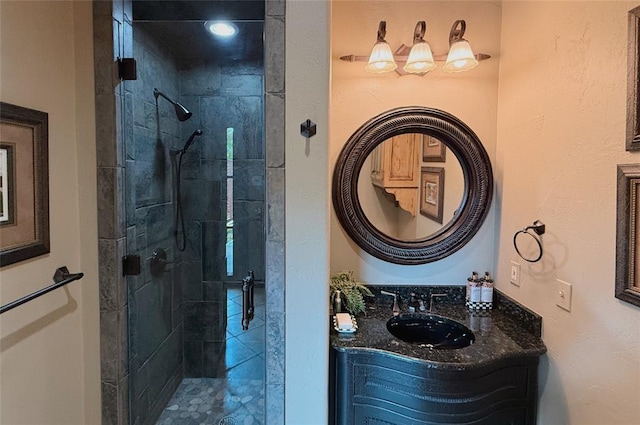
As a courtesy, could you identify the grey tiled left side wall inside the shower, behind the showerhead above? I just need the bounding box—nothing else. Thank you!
[123,26,184,424]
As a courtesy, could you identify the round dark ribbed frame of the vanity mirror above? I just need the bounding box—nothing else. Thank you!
[332,106,493,265]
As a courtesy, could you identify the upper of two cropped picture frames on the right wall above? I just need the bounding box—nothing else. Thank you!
[626,6,640,151]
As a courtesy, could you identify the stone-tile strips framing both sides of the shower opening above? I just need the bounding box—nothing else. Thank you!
[93,0,285,425]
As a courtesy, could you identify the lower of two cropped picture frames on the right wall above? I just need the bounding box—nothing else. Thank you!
[615,164,640,306]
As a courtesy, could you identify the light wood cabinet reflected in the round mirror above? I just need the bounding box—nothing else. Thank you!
[371,133,422,216]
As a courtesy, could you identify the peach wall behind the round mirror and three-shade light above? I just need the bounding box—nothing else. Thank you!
[329,0,501,284]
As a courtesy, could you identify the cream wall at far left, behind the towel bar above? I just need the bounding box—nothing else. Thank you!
[0,1,100,425]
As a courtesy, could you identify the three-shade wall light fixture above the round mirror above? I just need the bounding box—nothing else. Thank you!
[340,20,491,76]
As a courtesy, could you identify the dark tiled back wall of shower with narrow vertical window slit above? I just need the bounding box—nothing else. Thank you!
[178,55,265,377]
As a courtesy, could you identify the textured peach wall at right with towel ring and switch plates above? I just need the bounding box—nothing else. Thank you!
[496,1,640,425]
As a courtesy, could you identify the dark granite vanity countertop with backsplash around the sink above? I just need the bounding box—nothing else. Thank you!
[331,286,547,370]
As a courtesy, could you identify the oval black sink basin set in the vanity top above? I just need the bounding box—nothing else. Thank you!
[387,314,476,350]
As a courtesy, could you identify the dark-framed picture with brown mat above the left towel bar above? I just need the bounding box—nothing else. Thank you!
[0,102,50,267]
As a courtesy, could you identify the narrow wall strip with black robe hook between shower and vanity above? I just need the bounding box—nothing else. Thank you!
[285,0,330,425]
